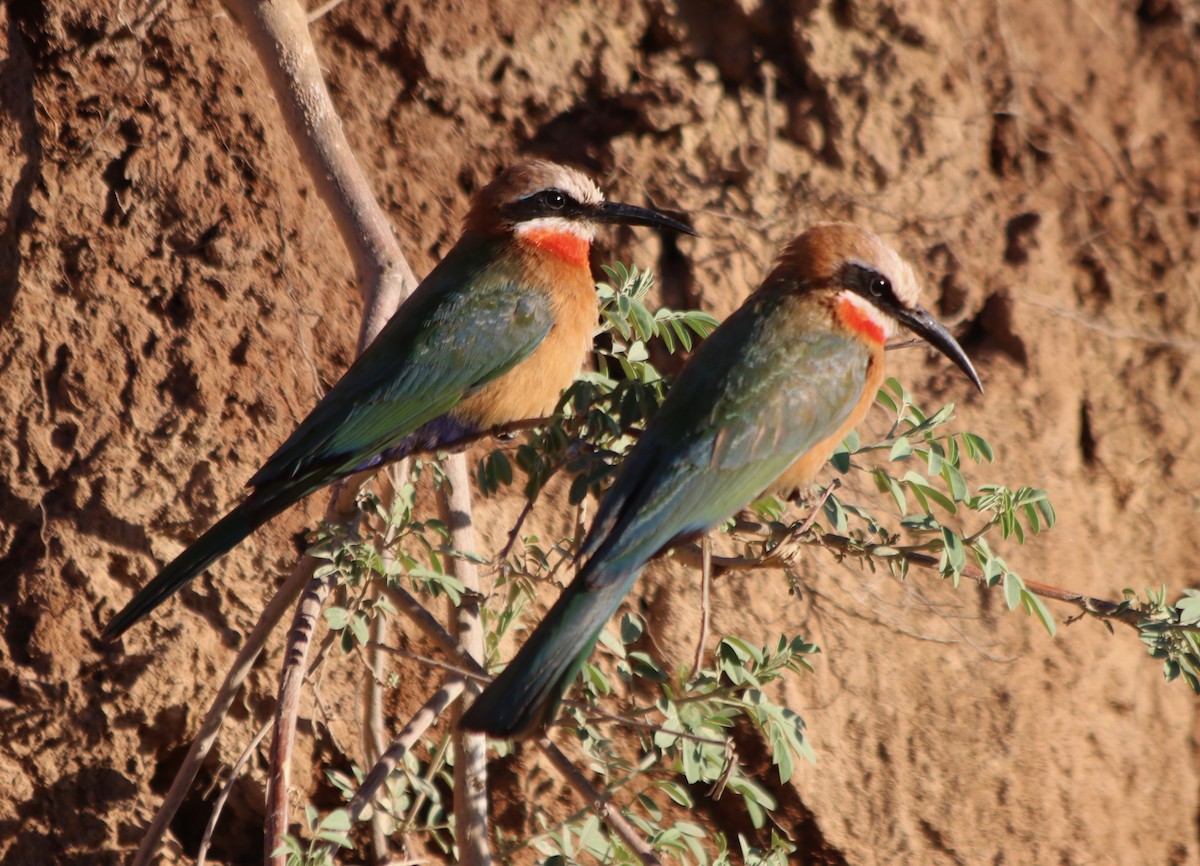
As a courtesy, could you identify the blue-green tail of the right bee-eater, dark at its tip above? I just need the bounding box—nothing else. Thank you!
[460,559,642,739]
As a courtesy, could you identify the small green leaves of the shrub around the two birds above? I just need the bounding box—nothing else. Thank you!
[278,265,1200,866]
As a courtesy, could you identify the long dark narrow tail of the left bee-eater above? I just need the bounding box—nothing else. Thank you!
[102,488,300,641]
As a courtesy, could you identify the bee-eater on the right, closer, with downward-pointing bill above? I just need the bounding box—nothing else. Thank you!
[461,223,983,738]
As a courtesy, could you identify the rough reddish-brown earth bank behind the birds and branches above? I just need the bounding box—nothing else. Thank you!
[0,0,1200,866]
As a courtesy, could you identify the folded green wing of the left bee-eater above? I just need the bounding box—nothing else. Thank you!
[250,242,553,487]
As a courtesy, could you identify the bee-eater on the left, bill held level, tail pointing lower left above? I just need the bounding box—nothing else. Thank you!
[104,161,696,639]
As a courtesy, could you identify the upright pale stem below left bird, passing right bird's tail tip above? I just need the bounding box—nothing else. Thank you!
[438,453,492,866]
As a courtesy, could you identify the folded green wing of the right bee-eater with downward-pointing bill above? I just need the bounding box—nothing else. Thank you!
[583,293,869,575]
